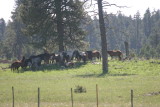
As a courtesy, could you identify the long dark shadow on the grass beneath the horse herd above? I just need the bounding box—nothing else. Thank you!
[15,62,87,73]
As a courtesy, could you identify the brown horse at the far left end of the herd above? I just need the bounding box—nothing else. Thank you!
[11,56,25,71]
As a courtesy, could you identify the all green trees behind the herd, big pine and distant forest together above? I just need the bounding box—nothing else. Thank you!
[0,0,160,59]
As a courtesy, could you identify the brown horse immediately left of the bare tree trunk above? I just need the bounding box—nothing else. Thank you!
[86,50,101,60]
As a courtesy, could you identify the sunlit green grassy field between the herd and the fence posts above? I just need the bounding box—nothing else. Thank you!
[0,60,160,107]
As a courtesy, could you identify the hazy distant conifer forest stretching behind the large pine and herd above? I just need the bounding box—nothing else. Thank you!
[0,0,160,59]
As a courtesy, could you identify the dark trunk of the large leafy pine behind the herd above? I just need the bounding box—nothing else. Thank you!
[56,0,64,52]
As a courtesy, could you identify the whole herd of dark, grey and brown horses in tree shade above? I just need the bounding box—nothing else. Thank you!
[11,50,122,71]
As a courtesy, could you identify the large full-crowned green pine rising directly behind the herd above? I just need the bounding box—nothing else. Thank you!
[20,0,85,51]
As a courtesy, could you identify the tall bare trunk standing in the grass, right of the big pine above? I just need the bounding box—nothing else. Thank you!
[98,0,108,74]
